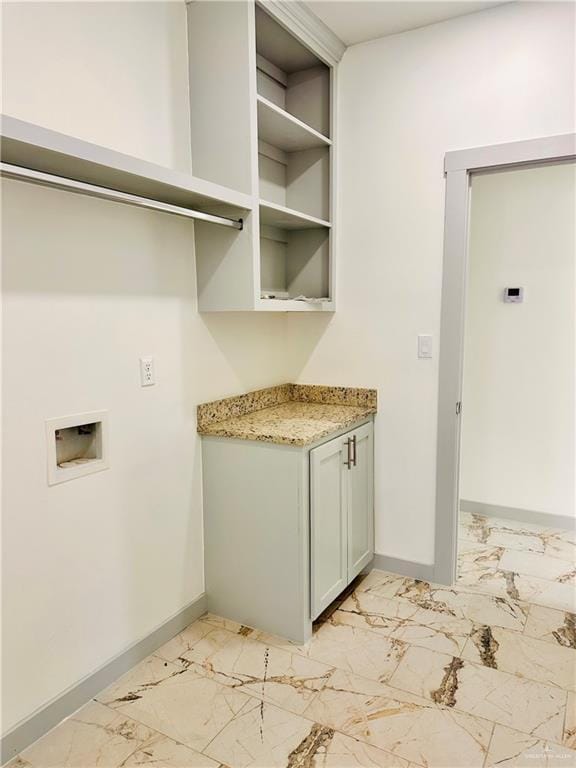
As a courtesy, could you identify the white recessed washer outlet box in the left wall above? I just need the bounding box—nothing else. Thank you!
[46,411,109,485]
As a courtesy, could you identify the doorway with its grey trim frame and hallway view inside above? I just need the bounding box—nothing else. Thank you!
[434,134,576,588]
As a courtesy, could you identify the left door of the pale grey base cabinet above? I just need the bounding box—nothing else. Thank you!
[310,435,348,619]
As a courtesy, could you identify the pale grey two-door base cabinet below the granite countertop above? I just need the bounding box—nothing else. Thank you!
[202,417,374,643]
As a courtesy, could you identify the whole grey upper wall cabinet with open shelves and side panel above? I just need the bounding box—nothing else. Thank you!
[187,0,343,312]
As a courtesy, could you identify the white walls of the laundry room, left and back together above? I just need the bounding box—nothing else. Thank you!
[3,3,573,729]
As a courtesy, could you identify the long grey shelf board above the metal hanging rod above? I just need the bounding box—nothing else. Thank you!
[1,115,252,211]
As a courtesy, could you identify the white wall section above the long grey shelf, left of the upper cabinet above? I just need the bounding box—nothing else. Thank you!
[2,2,190,171]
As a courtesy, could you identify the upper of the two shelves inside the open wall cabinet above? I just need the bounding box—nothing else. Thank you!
[258,96,332,152]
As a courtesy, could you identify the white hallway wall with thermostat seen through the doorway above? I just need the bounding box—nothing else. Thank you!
[460,164,576,517]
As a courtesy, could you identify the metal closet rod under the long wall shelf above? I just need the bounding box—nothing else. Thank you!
[0,163,243,229]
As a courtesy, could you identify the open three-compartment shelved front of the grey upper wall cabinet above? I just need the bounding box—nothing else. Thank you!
[255,5,334,312]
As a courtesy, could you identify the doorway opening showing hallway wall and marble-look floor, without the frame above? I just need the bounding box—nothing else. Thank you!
[457,162,576,611]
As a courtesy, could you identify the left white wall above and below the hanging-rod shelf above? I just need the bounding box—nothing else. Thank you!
[2,3,290,730]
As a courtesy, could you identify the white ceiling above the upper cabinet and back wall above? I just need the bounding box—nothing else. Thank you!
[306,0,509,45]
